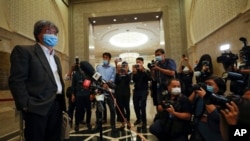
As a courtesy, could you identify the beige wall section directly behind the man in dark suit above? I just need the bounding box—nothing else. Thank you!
[0,0,69,137]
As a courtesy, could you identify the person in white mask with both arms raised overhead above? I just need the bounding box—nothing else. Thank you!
[178,54,194,97]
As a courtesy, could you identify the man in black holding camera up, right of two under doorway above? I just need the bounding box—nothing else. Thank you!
[132,57,150,129]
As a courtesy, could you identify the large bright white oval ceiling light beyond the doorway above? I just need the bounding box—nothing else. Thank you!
[109,32,148,48]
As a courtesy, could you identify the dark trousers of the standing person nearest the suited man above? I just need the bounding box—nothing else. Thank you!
[75,95,91,125]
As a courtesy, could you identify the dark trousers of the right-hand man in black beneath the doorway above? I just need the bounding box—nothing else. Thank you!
[133,90,148,122]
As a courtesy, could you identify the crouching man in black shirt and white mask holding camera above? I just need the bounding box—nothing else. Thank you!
[149,78,191,141]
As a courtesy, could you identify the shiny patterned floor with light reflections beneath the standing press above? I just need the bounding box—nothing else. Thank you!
[70,95,157,141]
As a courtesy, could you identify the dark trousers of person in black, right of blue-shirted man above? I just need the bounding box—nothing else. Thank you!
[116,94,130,122]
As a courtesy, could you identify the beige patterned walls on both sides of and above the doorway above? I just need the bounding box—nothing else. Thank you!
[0,0,250,137]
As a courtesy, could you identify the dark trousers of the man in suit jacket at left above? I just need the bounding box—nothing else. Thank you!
[23,100,62,141]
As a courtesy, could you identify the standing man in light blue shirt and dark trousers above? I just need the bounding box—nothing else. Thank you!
[95,52,117,132]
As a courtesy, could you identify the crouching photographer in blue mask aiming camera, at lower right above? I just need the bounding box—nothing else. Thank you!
[189,76,226,141]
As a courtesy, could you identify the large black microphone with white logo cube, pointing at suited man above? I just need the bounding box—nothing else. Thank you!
[80,61,115,89]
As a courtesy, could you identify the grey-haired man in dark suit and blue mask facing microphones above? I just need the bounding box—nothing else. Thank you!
[9,20,66,141]
